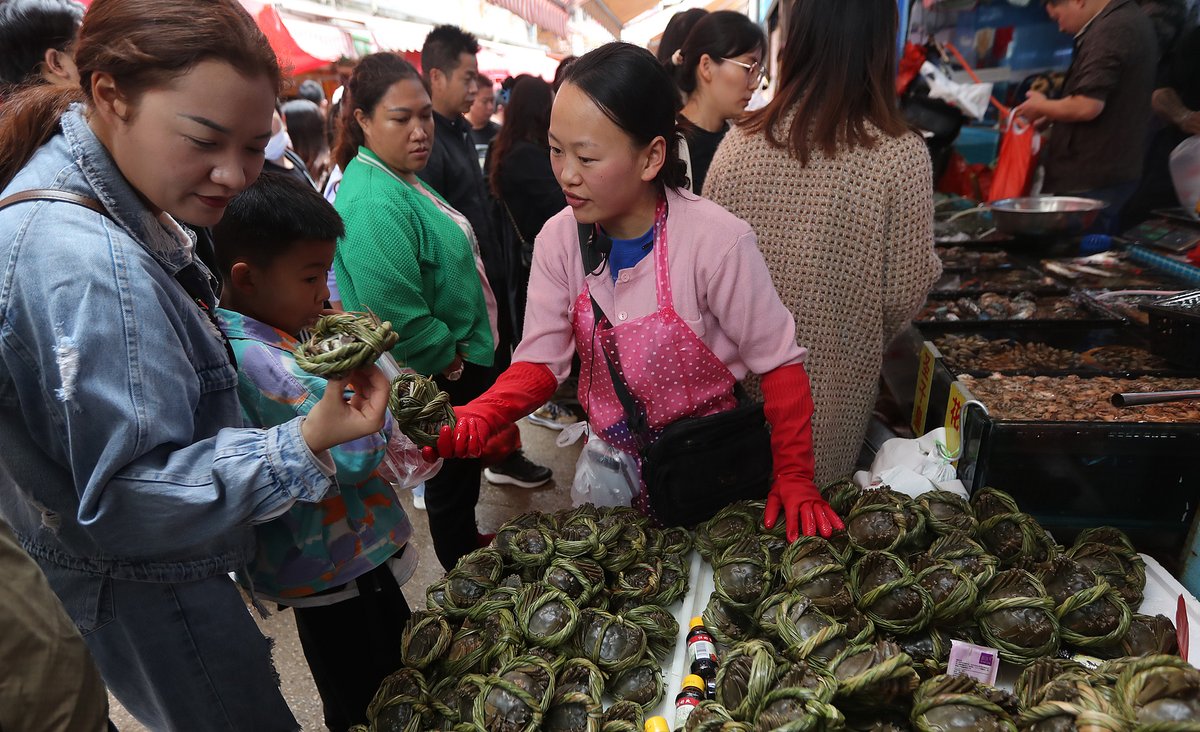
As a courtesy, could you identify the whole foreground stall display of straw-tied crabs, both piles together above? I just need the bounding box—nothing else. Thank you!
[343,489,1200,732]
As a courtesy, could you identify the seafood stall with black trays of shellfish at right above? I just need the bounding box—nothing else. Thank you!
[884,199,1200,572]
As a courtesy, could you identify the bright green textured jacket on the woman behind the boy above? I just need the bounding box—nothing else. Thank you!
[334,148,496,374]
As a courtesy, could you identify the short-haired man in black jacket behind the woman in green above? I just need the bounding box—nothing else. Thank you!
[418,25,552,496]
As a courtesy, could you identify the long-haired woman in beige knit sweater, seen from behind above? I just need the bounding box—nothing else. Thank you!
[704,0,942,485]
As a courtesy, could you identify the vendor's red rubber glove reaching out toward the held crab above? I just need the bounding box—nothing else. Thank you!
[421,361,558,462]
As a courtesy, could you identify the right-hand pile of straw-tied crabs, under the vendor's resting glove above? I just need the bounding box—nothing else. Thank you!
[685,481,1200,732]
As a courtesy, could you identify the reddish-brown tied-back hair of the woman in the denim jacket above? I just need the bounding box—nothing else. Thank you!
[0,0,283,188]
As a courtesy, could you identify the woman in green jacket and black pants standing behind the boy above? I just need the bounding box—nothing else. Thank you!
[334,53,496,570]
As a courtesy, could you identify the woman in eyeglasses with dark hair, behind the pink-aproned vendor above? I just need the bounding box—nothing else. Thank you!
[667,11,767,193]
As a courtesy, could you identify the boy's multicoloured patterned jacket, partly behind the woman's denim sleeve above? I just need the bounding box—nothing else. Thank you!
[217,308,416,597]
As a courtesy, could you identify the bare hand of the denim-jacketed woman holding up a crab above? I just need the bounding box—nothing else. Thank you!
[300,366,391,452]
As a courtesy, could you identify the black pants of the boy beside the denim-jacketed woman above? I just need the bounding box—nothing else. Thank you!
[295,556,410,732]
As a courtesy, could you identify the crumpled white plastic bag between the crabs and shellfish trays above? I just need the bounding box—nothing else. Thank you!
[854,427,967,498]
